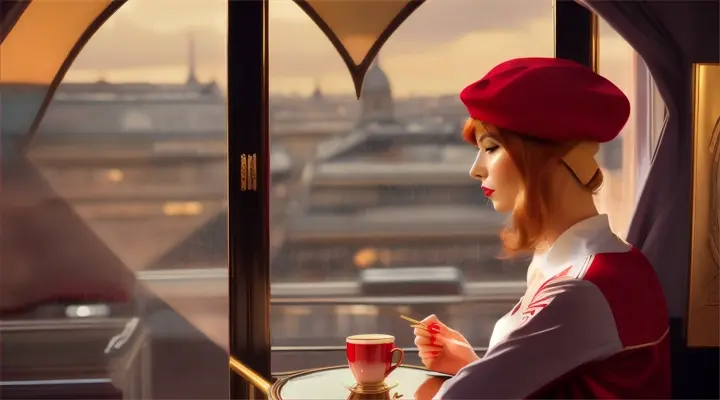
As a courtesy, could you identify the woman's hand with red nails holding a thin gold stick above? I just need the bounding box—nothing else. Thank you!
[414,315,479,375]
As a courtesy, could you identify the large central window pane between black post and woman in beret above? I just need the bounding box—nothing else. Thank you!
[270,0,553,372]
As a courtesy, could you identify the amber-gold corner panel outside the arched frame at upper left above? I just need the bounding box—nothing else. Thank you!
[0,0,125,139]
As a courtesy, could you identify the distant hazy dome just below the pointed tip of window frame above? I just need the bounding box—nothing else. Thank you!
[358,55,396,126]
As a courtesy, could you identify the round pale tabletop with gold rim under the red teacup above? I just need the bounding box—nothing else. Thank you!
[270,365,448,400]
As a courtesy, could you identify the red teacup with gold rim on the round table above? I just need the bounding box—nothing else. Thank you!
[345,334,405,385]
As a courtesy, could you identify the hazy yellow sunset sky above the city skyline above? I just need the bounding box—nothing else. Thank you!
[66,0,633,96]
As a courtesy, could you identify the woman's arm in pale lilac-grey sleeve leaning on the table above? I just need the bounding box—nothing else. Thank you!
[435,278,622,400]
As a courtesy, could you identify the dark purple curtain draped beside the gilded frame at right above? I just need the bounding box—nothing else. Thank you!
[585,0,720,318]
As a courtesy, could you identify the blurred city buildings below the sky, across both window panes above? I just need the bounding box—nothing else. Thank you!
[30,37,525,332]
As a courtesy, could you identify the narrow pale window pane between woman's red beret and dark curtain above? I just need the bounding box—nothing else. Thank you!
[596,19,665,236]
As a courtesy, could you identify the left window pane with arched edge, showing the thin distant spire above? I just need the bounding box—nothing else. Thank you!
[0,0,229,399]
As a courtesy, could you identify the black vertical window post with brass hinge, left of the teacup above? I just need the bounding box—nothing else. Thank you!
[227,0,270,399]
